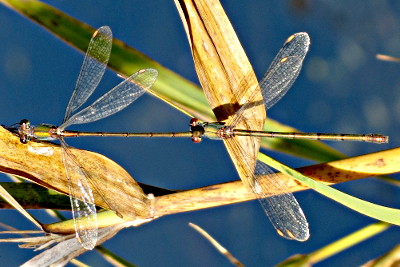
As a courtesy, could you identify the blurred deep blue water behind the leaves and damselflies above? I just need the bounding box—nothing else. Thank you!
[0,0,400,266]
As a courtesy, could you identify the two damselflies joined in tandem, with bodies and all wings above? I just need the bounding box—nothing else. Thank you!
[8,26,388,249]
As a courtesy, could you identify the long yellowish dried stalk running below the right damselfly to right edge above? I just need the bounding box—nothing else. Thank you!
[154,148,400,216]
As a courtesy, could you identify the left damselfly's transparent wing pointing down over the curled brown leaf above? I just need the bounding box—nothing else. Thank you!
[60,139,97,250]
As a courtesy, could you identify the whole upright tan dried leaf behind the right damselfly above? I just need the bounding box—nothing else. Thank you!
[175,0,266,191]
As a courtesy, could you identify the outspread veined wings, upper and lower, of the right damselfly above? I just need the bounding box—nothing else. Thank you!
[224,33,309,241]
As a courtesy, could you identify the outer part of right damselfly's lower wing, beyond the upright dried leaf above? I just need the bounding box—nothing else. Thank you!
[252,161,310,241]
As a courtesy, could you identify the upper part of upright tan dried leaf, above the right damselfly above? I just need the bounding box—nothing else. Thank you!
[175,0,265,121]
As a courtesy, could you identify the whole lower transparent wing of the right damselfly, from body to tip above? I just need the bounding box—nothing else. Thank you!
[224,137,309,241]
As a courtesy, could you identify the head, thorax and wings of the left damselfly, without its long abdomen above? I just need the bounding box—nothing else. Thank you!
[9,26,158,249]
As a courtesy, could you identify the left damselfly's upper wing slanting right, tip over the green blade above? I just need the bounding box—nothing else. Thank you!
[59,69,158,130]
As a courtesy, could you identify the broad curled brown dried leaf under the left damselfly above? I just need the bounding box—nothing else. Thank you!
[0,127,150,223]
